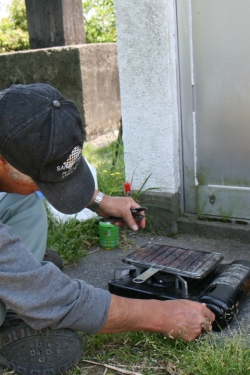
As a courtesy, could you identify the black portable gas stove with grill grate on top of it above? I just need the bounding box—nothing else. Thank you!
[109,242,250,330]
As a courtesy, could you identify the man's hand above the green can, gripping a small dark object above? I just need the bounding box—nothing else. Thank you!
[91,195,146,231]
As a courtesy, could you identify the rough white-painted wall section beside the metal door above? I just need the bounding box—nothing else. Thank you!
[115,0,180,194]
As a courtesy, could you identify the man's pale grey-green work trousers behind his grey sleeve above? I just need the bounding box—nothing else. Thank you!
[0,193,48,325]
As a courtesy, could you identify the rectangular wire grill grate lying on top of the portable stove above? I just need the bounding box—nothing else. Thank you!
[123,242,223,279]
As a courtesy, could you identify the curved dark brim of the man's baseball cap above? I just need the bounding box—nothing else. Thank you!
[34,157,95,215]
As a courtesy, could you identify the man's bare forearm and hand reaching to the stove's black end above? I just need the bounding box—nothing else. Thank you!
[99,295,215,341]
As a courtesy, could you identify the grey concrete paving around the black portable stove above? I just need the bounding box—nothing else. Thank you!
[65,231,250,340]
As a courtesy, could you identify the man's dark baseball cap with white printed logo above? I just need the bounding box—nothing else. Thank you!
[0,83,95,214]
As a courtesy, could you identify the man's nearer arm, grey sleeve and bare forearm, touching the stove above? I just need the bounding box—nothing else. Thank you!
[0,223,214,340]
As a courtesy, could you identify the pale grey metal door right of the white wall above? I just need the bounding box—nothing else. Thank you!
[176,0,250,219]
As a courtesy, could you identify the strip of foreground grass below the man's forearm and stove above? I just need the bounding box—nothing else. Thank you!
[71,331,250,375]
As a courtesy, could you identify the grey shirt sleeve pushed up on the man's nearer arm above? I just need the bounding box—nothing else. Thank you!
[0,222,111,334]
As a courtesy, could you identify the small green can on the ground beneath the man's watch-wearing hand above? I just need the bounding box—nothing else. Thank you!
[99,221,119,250]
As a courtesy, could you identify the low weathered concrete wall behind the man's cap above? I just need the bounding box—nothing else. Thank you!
[0,43,121,140]
